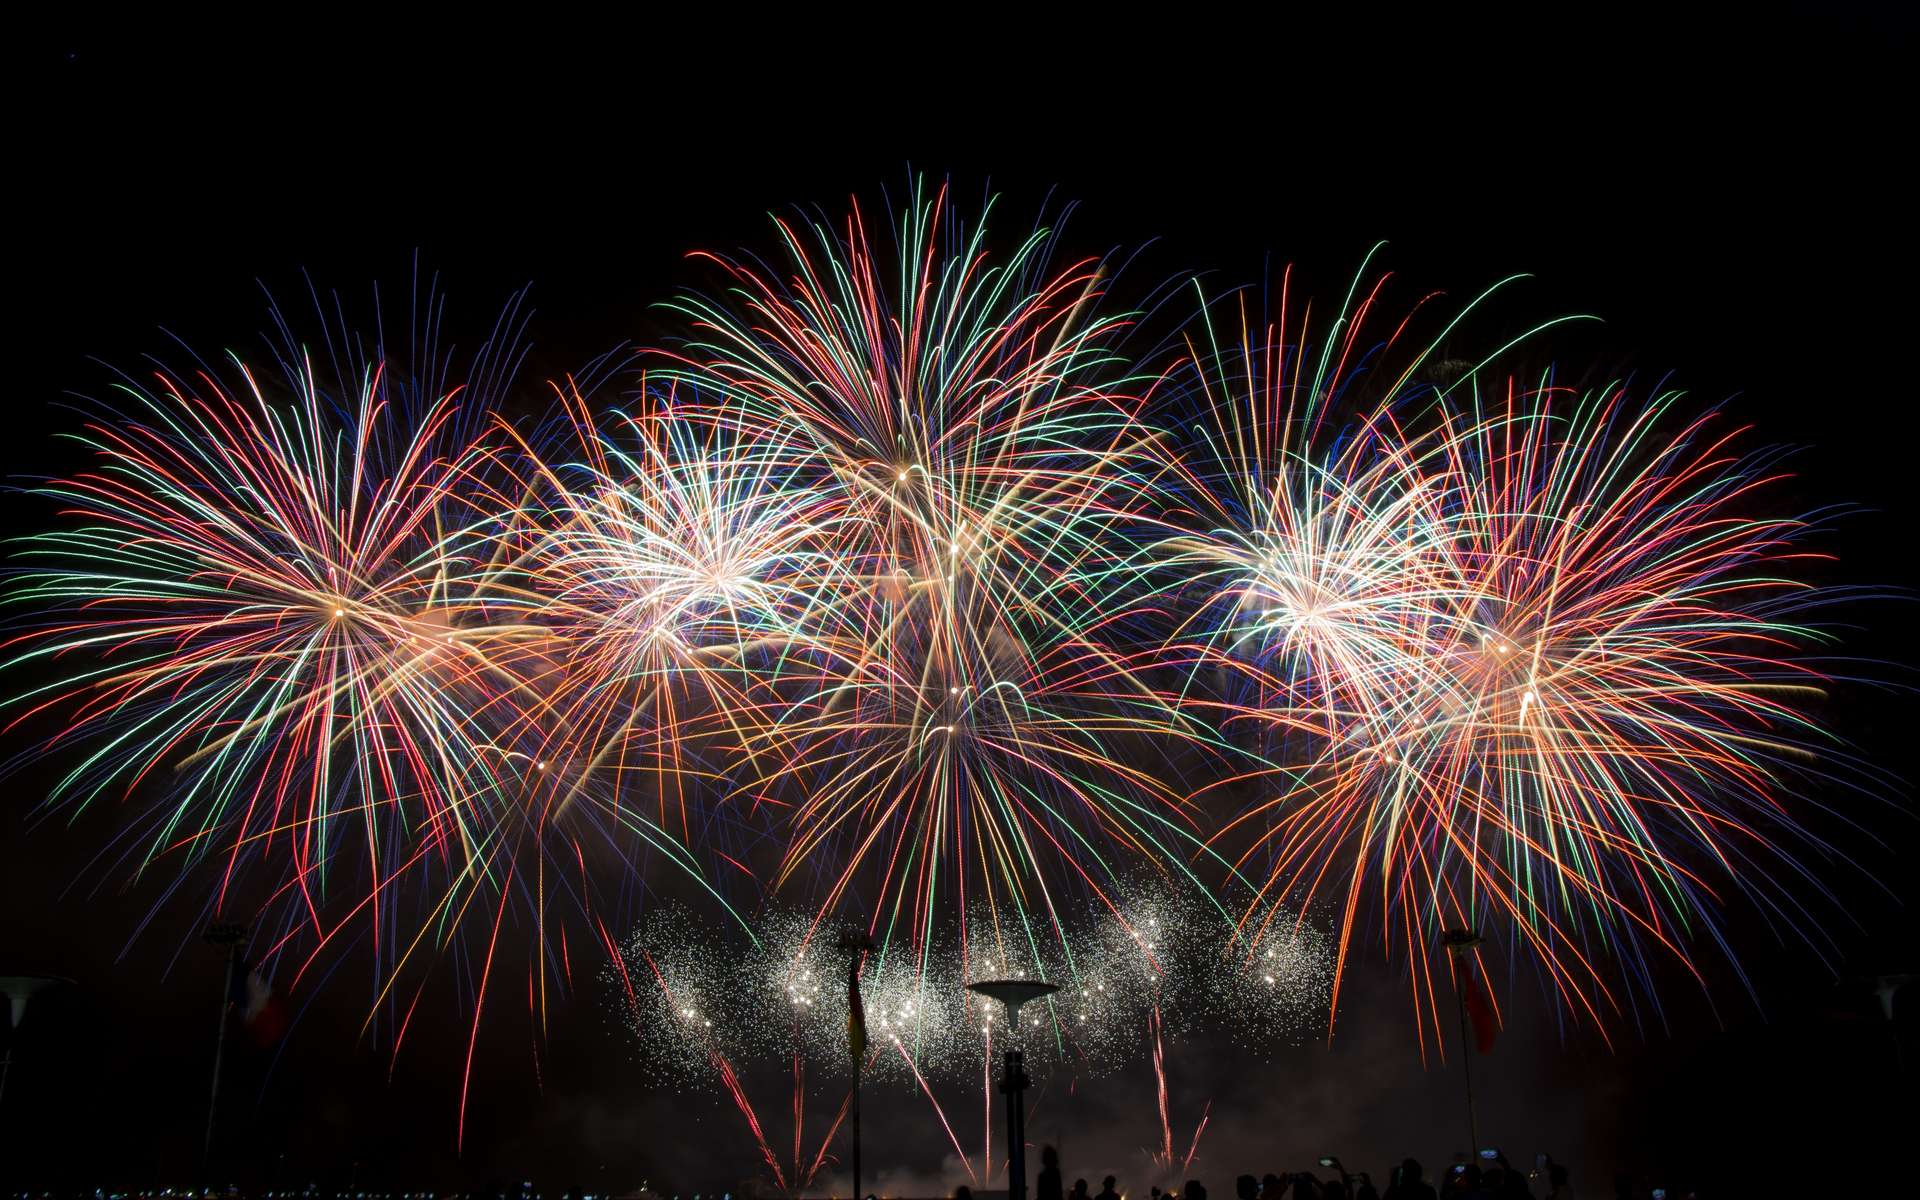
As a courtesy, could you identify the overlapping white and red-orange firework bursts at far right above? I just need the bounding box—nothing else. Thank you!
[1146,255,1873,1046]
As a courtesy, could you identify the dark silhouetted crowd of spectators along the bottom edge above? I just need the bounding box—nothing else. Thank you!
[954,1146,1635,1200]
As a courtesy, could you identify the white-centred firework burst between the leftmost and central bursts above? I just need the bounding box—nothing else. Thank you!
[491,384,847,843]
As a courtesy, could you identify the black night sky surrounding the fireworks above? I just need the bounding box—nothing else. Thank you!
[0,12,1920,1196]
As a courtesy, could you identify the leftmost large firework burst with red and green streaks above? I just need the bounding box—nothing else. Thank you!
[13,341,549,941]
